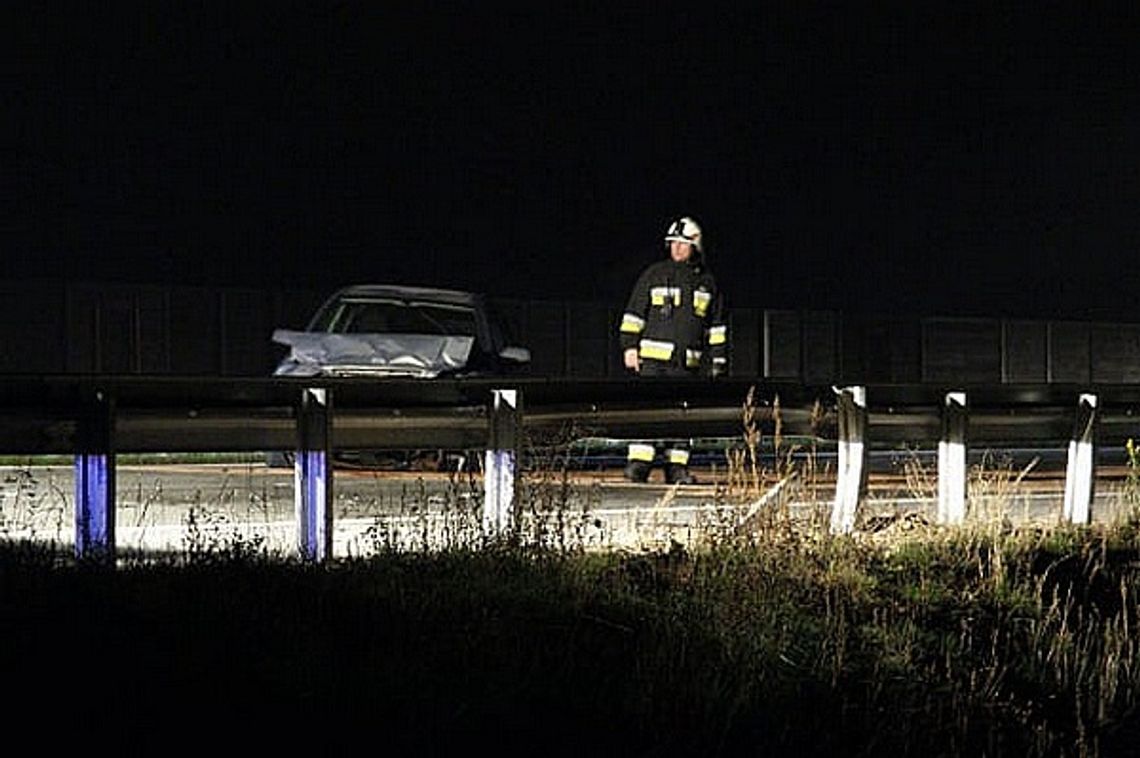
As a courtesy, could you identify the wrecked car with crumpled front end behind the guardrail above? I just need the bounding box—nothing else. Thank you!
[267,284,530,467]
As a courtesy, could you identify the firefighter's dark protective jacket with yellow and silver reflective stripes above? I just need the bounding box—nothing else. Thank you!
[619,259,728,376]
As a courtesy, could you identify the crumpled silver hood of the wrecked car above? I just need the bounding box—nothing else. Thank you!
[272,329,475,378]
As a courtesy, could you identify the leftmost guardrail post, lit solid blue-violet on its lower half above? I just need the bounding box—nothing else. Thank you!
[75,390,115,561]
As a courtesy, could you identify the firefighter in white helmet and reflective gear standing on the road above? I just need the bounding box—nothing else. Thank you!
[619,215,728,484]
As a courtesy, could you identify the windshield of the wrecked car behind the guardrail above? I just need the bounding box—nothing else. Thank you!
[315,299,477,336]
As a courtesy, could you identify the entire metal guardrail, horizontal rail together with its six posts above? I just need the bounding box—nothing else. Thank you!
[0,374,1140,560]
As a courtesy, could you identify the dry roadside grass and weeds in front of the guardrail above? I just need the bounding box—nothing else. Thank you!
[0,410,1140,758]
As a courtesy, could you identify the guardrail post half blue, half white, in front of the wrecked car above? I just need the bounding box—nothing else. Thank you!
[293,388,333,562]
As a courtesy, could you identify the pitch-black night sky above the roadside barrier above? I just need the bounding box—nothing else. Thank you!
[0,2,1140,319]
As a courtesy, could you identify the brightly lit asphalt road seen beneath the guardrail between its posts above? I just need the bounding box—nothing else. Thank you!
[0,464,1125,556]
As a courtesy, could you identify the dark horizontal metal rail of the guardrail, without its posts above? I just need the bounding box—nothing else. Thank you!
[0,375,1140,455]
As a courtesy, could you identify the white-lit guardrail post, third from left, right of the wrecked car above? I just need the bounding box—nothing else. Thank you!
[483,390,521,537]
